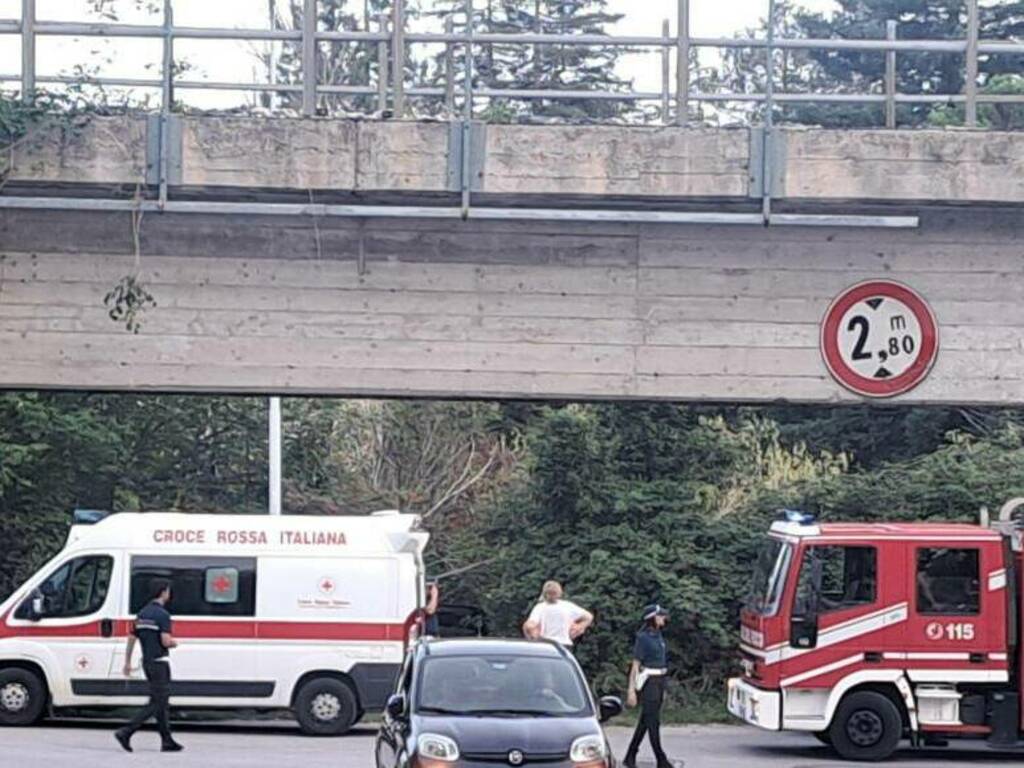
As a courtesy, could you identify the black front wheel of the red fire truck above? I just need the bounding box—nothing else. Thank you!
[828,690,903,761]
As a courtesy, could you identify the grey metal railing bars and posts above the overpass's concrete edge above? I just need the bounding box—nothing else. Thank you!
[0,0,1024,128]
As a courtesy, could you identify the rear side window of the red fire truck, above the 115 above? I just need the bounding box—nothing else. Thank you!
[918,547,981,615]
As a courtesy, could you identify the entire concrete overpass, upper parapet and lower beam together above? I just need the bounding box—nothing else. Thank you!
[0,115,1024,404]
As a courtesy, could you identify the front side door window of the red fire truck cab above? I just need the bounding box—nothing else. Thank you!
[795,545,879,615]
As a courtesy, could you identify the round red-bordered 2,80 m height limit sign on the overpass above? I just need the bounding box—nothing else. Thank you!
[821,281,939,397]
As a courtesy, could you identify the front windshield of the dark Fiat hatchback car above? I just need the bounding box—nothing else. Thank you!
[416,655,592,717]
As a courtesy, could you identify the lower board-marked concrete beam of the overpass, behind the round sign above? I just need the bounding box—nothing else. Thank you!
[0,208,1024,403]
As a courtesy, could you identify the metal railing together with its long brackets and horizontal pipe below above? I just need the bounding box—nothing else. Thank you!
[0,0,1024,227]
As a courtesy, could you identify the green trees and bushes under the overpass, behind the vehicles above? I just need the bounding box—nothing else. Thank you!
[0,393,1024,720]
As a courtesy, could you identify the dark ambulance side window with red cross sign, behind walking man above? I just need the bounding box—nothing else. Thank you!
[129,556,256,616]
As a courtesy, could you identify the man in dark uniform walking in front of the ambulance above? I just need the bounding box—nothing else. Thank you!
[114,579,184,752]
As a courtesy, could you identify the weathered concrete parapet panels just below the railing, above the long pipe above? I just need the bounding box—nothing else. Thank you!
[0,116,1024,203]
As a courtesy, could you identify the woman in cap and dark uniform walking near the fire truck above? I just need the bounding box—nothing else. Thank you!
[623,604,672,768]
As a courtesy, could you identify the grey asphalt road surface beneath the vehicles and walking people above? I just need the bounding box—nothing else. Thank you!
[6,721,1024,768]
